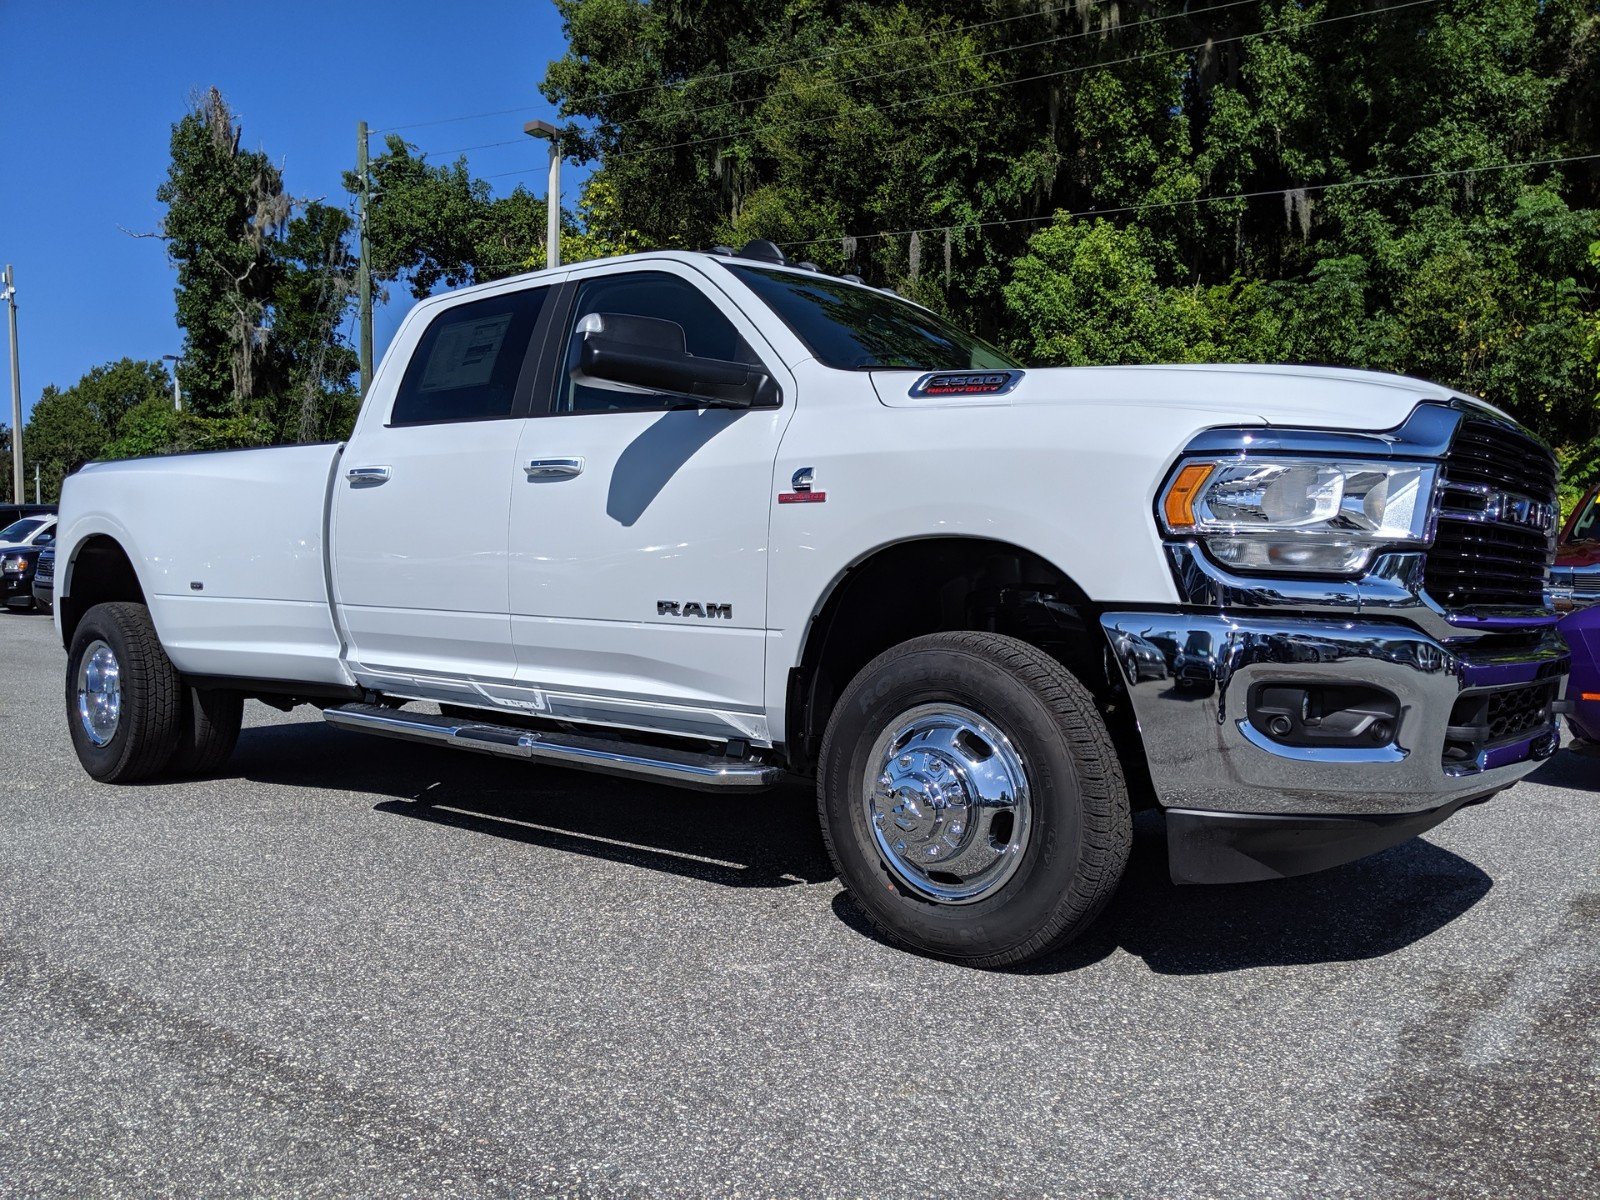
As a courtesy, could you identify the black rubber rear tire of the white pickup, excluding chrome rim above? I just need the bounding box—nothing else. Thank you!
[66,602,184,784]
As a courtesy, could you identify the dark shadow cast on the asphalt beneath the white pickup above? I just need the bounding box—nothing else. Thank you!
[232,723,1491,974]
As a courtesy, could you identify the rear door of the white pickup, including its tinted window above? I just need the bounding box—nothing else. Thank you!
[331,285,557,702]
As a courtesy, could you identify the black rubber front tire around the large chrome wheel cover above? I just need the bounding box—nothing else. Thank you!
[818,634,1133,966]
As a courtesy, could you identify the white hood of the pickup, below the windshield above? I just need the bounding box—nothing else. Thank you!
[872,365,1478,430]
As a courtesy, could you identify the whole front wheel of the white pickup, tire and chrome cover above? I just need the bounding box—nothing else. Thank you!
[818,634,1133,966]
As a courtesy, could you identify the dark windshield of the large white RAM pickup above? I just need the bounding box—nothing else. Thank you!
[725,262,1018,371]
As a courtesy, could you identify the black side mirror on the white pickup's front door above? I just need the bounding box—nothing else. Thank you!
[576,312,778,408]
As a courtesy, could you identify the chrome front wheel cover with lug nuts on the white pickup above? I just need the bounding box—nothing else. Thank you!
[862,704,1032,904]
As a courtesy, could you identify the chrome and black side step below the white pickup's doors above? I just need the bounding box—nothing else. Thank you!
[322,704,784,792]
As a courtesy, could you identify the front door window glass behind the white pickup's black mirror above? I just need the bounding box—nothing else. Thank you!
[555,270,760,413]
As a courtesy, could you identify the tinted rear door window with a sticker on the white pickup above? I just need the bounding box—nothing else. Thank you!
[389,288,550,426]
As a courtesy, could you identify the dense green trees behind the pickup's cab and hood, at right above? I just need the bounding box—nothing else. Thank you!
[542,0,1600,499]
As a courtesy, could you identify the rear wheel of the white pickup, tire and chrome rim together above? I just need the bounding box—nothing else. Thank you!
[67,602,182,784]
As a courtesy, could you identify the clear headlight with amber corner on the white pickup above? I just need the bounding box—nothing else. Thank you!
[1162,458,1435,574]
